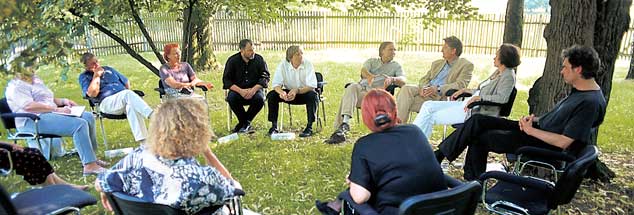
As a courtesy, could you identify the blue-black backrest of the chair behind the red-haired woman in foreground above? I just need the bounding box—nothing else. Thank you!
[399,181,482,215]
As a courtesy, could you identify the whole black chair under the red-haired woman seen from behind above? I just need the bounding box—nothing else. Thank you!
[339,175,482,215]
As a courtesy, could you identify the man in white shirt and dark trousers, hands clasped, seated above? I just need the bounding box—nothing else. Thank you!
[266,46,319,137]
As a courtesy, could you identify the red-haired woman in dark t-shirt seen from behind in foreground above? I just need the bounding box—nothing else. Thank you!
[317,89,447,214]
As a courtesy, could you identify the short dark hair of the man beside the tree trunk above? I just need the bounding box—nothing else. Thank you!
[561,45,601,79]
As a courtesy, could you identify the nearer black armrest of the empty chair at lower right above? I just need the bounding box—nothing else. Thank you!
[480,171,555,192]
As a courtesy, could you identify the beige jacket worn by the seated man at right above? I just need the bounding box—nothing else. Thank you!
[418,58,473,98]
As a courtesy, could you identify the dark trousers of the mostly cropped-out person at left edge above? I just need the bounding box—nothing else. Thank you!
[0,142,53,185]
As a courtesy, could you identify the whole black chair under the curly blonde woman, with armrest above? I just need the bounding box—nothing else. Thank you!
[106,190,244,215]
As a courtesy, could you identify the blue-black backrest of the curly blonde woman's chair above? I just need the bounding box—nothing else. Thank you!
[106,192,222,215]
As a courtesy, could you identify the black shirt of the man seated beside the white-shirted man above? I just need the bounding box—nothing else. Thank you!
[222,52,271,89]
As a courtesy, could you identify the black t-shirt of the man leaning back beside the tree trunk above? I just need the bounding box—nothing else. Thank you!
[538,88,607,150]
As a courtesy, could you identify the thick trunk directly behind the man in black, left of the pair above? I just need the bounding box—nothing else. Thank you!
[528,0,597,115]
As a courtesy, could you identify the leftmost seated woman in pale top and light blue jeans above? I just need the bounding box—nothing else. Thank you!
[5,55,107,175]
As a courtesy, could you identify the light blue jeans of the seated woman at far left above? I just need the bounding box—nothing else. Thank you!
[18,112,97,165]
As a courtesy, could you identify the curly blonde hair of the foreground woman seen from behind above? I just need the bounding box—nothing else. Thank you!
[146,98,213,159]
